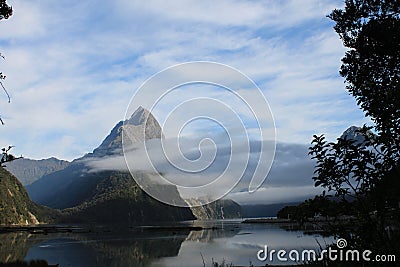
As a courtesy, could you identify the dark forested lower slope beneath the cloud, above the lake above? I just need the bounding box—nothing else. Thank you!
[62,171,195,224]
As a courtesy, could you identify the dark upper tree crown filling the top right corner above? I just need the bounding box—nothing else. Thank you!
[329,0,400,150]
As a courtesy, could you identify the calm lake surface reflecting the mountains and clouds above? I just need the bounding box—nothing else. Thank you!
[0,220,334,267]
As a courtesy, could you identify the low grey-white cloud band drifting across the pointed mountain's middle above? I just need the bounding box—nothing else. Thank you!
[86,138,321,204]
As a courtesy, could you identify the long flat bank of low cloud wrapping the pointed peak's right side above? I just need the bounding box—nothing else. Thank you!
[86,139,321,203]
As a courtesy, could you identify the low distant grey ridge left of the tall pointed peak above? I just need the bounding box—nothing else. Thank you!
[6,157,70,185]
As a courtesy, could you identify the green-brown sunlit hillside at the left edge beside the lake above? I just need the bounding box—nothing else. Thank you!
[0,167,57,225]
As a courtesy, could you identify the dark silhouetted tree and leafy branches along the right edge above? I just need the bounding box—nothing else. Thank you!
[309,0,400,254]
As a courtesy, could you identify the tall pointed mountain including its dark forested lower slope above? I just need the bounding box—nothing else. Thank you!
[26,107,195,223]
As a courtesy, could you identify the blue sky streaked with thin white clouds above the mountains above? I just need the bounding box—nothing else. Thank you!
[0,0,369,205]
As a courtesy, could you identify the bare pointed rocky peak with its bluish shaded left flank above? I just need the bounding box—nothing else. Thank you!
[26,107,166,209]
